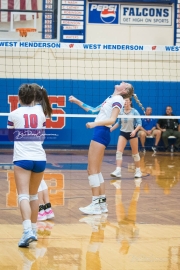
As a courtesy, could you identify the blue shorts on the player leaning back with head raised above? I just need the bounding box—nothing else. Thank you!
[92,126,111,147]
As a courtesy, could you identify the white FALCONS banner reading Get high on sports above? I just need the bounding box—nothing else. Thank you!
[120,5,172,26]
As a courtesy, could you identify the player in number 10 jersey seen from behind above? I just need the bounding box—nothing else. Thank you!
[7,84,52,247]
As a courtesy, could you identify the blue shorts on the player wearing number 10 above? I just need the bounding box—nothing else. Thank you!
[13,160,46,173]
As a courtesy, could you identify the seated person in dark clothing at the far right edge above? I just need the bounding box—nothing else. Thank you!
[157,106,180,152]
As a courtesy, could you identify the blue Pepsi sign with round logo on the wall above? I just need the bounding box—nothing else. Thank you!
[88,3,119,24]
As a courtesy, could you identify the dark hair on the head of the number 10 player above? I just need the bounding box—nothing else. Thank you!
[18,84,34,105]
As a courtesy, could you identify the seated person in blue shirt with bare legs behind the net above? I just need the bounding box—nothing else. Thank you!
[138,107,161,153]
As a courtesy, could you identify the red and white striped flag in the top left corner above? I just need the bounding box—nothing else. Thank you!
[0,0,38,22]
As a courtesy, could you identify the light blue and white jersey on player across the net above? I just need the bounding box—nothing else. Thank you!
[119,108,142,132]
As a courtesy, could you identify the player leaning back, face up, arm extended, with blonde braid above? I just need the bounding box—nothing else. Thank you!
[69,82,134,215]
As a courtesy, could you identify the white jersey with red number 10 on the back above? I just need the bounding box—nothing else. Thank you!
[7,105,46,161]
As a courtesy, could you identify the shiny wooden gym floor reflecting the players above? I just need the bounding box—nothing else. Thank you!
[0,150,180,270]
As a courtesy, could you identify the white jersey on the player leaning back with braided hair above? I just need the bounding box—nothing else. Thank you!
[95,95,125,127]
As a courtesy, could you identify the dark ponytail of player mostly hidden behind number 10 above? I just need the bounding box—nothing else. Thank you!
[32,83,52,117]
